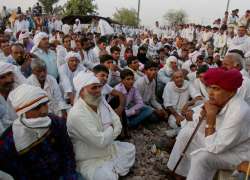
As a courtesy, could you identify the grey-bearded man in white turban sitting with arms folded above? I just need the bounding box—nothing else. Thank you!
[67,72,135,180]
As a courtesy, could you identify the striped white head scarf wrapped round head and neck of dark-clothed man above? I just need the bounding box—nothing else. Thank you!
[9,84,51,152]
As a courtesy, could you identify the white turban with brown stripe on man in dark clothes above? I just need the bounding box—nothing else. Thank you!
[8,84,49,116]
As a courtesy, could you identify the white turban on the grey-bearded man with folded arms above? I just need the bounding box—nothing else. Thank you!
[73,71,100,97]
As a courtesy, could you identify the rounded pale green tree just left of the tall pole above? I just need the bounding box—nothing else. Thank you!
[113,8,138,26]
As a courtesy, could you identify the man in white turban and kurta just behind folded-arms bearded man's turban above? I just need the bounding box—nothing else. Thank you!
[59,51,86,105]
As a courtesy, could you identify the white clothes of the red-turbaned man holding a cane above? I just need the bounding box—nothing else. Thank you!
[168,95,250,180]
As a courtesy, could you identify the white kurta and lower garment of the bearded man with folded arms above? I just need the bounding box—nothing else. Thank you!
[67,98,135,180]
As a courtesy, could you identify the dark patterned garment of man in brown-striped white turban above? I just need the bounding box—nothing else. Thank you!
[0,116,77,180]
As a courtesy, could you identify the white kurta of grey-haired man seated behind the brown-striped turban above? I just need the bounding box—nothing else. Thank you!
[27,74,69,116]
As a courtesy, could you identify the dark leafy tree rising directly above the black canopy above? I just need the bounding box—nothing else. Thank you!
[64,0,97,16]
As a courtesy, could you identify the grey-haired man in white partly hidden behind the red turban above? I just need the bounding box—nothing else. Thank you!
[222,53,250,105]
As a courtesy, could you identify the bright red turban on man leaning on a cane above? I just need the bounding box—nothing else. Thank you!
[204,68,243,91]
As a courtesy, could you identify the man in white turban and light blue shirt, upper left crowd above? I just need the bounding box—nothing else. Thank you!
[31,32,58,79]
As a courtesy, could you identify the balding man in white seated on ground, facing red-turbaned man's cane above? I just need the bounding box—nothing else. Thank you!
[162,71,200,137]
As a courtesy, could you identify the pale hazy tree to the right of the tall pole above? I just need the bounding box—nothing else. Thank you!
[164,9,187,26]
